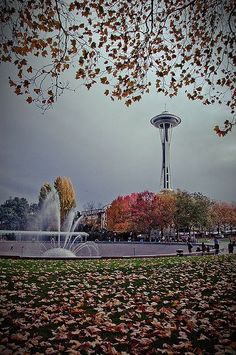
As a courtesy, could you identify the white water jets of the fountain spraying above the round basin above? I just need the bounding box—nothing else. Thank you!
[0,188,100,258]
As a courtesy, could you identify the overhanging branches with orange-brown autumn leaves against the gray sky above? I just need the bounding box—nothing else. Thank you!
[0,0,235,135]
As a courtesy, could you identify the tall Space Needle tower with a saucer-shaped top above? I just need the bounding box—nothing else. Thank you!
[150,111,181,190]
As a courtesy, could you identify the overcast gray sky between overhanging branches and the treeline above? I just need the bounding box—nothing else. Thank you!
[0,66,236,210]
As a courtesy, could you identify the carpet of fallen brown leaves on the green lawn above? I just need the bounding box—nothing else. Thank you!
[0,255,236,355]
